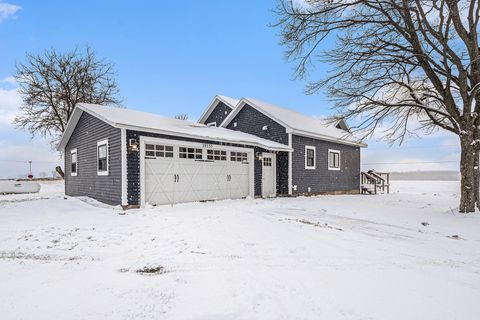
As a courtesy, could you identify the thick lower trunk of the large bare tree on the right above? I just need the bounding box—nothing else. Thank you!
[458,138,479,213]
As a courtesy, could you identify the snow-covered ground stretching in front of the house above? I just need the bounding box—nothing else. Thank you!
[0,181,480,320]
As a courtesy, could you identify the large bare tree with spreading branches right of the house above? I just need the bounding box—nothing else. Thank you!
[275,0,480,212]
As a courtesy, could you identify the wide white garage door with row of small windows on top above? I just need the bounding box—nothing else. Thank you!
[142,140,253,205]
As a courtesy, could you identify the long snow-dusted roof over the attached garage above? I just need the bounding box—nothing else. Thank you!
[57,103,291,151]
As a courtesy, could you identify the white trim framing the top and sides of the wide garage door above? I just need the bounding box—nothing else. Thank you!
[139,136,255,208]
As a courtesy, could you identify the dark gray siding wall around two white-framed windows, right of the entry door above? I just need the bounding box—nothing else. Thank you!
[292,135,360,194]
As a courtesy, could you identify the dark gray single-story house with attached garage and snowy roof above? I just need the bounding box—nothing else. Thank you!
[58,95,365,207]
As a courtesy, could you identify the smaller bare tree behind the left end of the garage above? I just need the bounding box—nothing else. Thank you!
[14,47,120,142]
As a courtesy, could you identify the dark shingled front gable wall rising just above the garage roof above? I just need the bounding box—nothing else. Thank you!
[227,105,288,145]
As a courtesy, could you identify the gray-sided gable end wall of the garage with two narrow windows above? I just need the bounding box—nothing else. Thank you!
[65,112,122,205]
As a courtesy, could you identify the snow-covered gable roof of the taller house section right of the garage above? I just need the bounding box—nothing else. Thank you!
[221,98,367,147]
